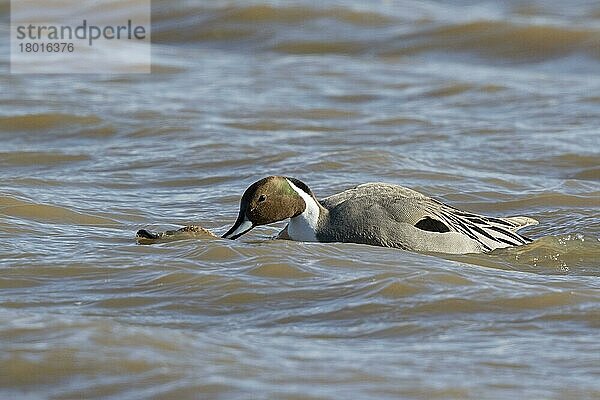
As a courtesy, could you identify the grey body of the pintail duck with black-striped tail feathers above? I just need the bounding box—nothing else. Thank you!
[319,183,537,253]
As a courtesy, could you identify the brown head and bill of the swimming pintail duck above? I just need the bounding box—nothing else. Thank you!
[223,176,312,239]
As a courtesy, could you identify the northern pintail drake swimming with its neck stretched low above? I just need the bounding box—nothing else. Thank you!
[223,176,538,254]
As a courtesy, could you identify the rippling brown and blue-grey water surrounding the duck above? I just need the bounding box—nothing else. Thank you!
[0,0,600,399]
